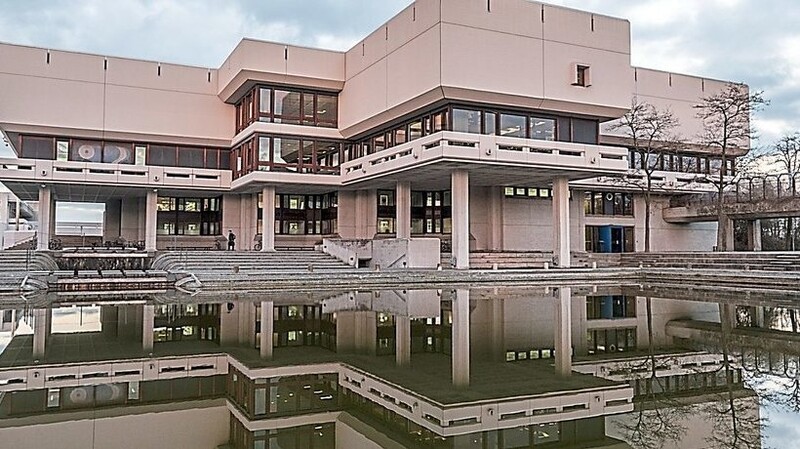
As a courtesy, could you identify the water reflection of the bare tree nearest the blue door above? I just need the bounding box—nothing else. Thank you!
[617,297,690,449]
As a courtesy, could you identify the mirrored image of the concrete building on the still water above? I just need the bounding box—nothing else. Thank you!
[0,287,768,448]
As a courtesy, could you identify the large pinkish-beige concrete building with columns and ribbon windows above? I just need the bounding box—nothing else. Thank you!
[0,0,740,268]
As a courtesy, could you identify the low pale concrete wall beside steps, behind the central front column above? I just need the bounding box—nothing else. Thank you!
[322,238,441,270]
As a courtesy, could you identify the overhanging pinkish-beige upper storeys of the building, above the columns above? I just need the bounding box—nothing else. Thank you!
[0,0,744,200]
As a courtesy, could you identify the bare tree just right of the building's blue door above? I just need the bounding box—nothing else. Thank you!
[610,98,679,252]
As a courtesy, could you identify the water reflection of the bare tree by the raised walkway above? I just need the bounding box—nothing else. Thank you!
[705,304,765,449]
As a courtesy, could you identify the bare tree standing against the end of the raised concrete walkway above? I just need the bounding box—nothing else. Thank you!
[694,83,768,251]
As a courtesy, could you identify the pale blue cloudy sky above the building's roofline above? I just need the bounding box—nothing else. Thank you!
[0,0,800,223]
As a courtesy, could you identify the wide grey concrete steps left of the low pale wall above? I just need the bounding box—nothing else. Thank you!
[151,250,356,276]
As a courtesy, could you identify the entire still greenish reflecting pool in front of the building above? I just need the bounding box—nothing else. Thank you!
[0,283,800,449]
